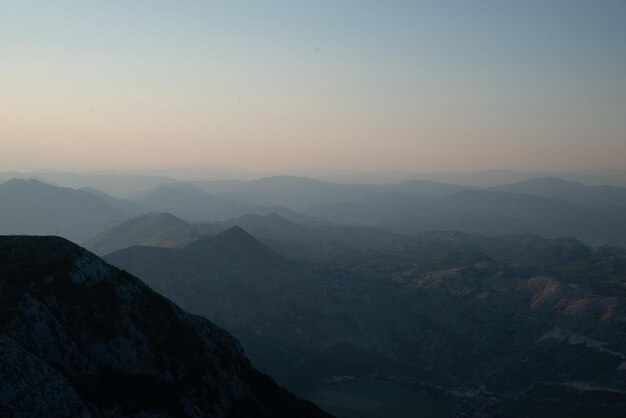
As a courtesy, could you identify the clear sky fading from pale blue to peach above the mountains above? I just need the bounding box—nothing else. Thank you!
[0,0,626,172]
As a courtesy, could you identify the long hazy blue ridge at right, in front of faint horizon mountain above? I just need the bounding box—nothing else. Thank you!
[306,189,626,246]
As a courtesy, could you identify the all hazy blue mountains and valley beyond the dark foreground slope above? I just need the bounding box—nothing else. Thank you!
[0,169,626,416]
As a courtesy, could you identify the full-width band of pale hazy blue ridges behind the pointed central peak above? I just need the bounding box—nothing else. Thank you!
[7,177,626,248]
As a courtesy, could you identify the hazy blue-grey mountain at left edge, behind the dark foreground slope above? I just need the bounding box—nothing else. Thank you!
[0,179,128,241]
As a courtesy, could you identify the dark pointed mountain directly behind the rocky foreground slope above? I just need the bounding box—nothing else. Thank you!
[105,227,386,389]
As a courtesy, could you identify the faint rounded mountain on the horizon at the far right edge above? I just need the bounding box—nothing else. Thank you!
[494,177,626,208]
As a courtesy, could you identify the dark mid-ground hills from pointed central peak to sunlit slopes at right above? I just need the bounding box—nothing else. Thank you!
[106,228,626,417]
